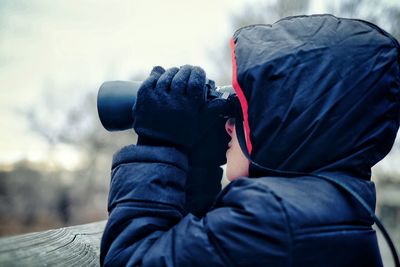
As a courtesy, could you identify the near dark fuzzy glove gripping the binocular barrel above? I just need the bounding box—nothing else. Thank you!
[133,65,207,154]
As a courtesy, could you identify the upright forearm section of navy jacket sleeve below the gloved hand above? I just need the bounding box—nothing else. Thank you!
[108,145,188,215]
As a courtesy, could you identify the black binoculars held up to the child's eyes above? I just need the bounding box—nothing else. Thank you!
[97,80,238,131]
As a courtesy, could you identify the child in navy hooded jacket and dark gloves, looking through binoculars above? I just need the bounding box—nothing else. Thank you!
[100,15,400,267]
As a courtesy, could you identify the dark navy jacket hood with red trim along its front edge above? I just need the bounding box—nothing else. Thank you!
[231,15,400,179]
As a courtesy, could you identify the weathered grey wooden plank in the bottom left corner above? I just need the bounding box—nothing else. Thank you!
[0,221,106,266]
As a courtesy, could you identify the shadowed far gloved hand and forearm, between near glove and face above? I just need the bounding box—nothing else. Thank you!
[185,82,230,217]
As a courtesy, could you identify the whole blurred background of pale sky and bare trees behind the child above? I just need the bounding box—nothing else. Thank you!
[0,0,400,266]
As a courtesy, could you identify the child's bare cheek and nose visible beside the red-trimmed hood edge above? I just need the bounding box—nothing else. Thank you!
[225,119,249,181]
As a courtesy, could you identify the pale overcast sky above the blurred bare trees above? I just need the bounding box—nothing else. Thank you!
[0,0,400,173]
